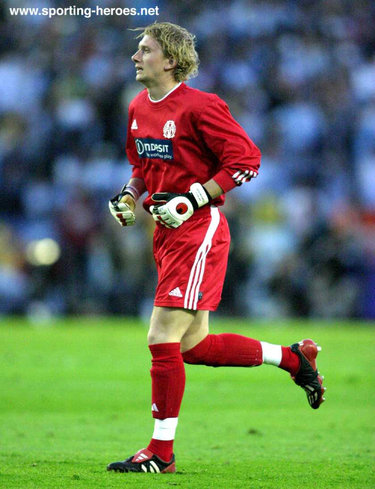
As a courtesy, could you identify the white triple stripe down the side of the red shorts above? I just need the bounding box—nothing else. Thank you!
[184,207,220,310]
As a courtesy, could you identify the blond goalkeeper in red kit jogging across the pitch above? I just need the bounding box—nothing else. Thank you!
[108,22,324,472]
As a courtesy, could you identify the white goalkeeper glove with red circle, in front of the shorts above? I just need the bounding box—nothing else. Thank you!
[150,183,211,228]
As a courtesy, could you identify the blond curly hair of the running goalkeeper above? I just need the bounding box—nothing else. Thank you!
[132,22,199,82]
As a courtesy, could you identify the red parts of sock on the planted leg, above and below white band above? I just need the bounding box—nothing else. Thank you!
[147,343,185,462]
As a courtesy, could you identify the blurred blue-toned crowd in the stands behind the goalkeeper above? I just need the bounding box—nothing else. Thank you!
[0,0,375,318]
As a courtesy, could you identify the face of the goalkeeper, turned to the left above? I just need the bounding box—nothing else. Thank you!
[132,35,169,87]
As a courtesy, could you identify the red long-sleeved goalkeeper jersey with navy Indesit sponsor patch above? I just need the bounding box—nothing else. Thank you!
[126,83,261,210]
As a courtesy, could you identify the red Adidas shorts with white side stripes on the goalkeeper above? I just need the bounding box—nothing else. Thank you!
[154,207,230,311]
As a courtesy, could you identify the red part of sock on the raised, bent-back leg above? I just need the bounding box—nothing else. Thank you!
[182,333,263,367]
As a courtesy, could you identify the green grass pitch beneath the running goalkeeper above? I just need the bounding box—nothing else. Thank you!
[0,318,375,489]
